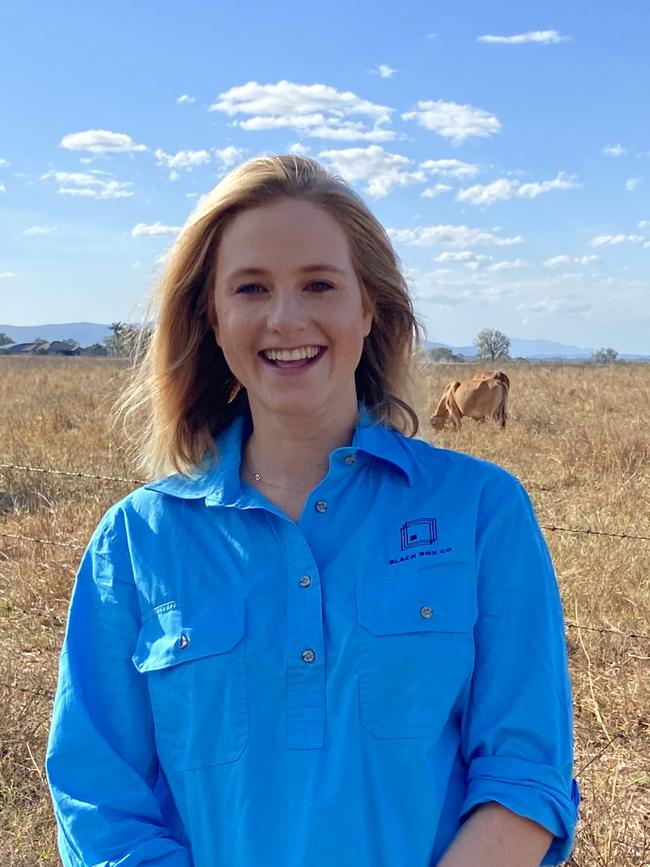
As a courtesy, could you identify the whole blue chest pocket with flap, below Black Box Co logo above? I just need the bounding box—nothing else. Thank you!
[357,563,478,740]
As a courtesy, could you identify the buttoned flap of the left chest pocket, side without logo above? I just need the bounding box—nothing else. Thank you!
[132,597,245,672]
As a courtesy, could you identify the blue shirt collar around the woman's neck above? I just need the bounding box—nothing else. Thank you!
[144,403,414,506]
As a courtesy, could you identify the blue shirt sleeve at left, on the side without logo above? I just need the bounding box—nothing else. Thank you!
[45,507,192,867]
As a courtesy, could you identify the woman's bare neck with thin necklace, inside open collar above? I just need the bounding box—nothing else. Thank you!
[242,404,357,493]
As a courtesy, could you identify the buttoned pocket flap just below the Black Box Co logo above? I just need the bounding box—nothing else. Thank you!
[357,563,478,635]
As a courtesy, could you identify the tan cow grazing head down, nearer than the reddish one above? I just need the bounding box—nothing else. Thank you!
[430,371,510,430]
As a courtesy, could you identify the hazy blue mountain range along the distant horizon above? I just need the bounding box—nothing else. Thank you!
[0,322,650,361]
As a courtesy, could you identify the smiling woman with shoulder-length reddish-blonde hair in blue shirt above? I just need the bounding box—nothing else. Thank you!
[46,156,578,867]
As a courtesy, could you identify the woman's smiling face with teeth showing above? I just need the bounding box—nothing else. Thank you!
[214,199,372,423]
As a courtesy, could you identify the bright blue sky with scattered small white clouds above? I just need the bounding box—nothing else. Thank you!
[0,0,650,354]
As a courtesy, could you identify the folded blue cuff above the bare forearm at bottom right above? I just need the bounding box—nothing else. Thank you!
[460,756,580,865]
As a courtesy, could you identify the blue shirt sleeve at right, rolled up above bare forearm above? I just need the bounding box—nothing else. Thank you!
[461,472,580,865]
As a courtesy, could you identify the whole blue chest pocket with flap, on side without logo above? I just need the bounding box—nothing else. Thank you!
[133,596,249,771]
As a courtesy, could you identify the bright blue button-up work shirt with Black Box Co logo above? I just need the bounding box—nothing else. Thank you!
[46,407,579,867]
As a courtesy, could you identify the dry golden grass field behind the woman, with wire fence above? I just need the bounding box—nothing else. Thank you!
[0,358,650,867]
